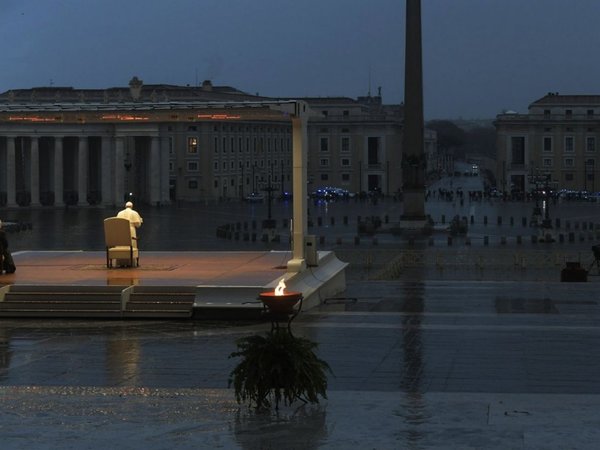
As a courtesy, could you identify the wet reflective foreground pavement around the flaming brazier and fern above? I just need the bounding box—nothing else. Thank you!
[0,281,600,449]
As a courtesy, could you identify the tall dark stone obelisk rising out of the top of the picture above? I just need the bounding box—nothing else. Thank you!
[400,0,426,230]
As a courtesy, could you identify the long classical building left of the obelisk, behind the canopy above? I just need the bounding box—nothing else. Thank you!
[0,77,435,207]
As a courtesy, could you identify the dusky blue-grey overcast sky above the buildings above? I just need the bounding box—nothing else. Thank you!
[0,0,600,119]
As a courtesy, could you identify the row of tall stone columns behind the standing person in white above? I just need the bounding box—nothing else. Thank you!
[0,133,170,207]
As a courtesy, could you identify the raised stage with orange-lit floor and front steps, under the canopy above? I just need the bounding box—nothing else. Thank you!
[0,251,347,320]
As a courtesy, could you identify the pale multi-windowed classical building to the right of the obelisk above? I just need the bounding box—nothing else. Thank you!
[495,93,600,192]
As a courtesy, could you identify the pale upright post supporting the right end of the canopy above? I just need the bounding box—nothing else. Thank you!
[287,114,308,272]
